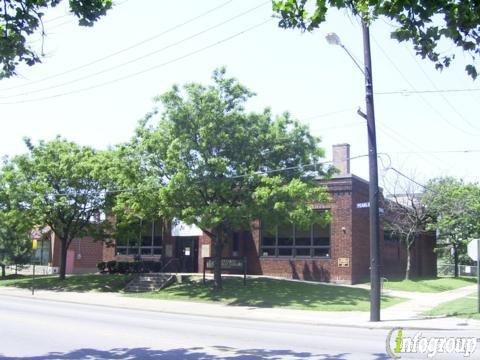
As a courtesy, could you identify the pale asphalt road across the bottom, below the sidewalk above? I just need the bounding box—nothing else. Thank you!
[0,296,466,360]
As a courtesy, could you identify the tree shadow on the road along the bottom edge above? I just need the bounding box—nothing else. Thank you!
[0,346,388,360]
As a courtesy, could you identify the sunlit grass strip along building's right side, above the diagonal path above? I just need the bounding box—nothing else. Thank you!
[370,277,477,293]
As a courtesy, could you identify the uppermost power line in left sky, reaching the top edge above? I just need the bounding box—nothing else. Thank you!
[1,0,234,93]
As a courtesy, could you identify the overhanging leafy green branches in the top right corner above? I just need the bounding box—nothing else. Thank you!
[272,0,480,79]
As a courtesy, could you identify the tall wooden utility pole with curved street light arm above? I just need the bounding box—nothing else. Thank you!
[326,21,380,321]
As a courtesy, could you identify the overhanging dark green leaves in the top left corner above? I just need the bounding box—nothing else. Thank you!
[0,0,112,79]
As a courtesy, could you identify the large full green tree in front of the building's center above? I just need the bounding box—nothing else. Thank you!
[120,69,327,290]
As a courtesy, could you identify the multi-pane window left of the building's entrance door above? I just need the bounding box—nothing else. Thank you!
[117,221,162,255]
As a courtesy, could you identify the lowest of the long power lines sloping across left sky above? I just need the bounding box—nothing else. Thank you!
[0,18,272,105]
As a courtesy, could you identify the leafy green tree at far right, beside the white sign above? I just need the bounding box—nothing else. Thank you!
[423,177,480,277]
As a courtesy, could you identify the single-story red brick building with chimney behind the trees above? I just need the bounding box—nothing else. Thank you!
[36,144,436,284]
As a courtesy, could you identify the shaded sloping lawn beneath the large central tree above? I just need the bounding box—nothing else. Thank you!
[129,278,404,311]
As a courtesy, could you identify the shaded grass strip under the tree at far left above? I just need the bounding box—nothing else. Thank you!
[0,274,132,292]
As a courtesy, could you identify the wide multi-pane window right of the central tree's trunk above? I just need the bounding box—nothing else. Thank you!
[261,218,330,258]
